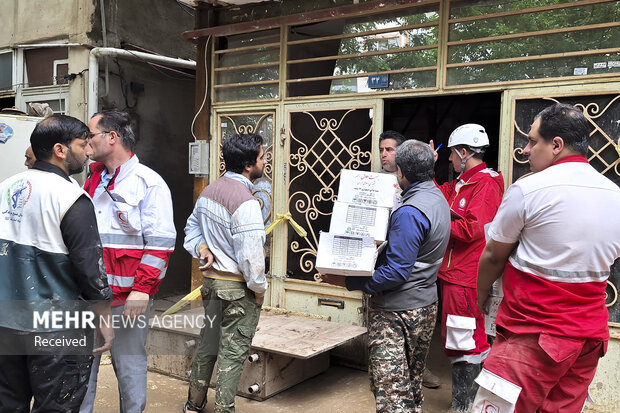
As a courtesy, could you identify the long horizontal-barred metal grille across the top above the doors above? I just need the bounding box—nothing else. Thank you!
[209,0,620,104]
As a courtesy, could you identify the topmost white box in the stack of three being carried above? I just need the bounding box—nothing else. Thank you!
[338,169,399,208]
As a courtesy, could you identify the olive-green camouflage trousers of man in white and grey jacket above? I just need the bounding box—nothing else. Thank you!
[187,278,261,413]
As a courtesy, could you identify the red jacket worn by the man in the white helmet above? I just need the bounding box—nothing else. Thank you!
[437,162,504,288]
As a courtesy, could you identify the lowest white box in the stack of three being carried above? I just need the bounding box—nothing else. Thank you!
[316,232,379,276]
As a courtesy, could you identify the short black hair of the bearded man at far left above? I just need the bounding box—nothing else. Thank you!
[30,115,90,161]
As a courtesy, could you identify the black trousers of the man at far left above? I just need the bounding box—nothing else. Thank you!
[0,328,93,413]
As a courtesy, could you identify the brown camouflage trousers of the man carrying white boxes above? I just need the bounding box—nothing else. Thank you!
[368,303,437,413]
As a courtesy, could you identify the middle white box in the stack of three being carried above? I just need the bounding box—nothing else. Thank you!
[329,201,390,242]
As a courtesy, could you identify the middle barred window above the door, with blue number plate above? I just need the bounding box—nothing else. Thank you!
[286,2,439,97]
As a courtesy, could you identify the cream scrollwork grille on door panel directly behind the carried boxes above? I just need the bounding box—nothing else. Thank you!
[286,108,373,280]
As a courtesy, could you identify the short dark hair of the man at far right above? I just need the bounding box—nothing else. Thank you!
[534,103,590,156]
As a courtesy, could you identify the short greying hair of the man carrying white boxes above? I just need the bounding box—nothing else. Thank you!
[395,139,435,183]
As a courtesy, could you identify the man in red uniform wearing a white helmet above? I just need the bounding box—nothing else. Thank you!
[438,123,504,412]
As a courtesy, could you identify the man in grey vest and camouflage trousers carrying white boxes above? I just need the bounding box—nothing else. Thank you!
[323,140,450,412]
